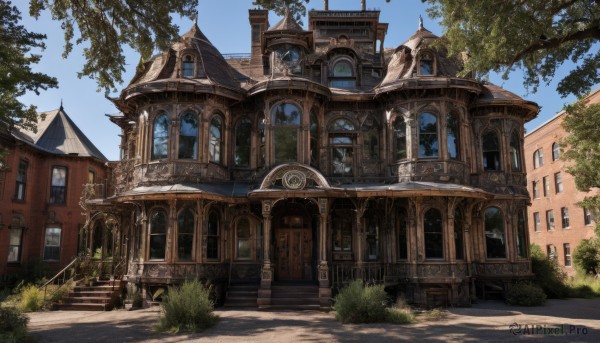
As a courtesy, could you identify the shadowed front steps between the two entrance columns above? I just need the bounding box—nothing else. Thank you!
[268,283,321,311]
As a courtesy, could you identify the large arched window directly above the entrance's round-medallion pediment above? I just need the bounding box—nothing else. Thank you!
[271,102,302,163]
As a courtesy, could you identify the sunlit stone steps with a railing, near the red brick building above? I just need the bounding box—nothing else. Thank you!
[52,280,122,311]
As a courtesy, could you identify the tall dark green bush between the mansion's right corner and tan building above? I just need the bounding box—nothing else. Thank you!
[531,244,569,299]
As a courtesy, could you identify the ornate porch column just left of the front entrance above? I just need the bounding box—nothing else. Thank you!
[256,200,273,307]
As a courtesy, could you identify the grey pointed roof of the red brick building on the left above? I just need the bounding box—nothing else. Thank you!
[13,106,108,161]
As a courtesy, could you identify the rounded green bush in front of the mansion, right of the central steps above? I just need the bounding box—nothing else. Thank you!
[334,280,388,323]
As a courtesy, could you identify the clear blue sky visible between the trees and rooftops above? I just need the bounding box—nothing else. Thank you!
[14,0,575,160]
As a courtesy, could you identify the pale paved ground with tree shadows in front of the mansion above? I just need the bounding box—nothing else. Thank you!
[29,299,600,343]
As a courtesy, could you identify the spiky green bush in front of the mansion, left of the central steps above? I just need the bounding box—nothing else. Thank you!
[157,280,218,332]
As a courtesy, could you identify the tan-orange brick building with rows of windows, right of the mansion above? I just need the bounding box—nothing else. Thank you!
[525,88,600,275]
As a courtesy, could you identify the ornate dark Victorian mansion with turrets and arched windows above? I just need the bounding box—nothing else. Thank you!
[86,2,538,307]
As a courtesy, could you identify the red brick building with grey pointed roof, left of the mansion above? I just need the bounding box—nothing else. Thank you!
[0,106,107,282]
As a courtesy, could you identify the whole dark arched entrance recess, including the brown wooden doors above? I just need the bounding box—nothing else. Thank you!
[273,199,318,281]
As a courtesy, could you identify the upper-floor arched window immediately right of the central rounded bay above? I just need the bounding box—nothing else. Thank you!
[329,118,354,176]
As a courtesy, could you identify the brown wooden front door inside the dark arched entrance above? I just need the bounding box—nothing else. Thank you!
[275,216,312,281]
